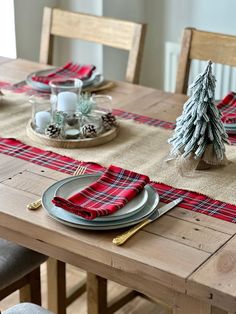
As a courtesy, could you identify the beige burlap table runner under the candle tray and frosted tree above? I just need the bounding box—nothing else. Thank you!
[0,94,236,205]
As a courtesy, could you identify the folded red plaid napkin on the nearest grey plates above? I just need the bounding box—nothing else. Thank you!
[52,165,149,220]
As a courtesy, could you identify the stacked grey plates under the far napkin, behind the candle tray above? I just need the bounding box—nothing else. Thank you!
[26,69,104,92]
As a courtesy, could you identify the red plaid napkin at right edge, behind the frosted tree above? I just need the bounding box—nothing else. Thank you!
[217,92,236,124]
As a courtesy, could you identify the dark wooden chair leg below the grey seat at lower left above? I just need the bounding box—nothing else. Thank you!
[19,267,41,305]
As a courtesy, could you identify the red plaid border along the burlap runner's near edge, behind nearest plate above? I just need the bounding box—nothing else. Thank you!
[0,138,236,223]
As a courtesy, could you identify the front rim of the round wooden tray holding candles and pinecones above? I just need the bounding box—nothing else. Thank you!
[26,120,118,148]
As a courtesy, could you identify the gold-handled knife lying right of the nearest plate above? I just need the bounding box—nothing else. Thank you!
[112,197,183,245]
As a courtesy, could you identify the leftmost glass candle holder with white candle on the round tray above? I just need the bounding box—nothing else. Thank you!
[29,95,52,134]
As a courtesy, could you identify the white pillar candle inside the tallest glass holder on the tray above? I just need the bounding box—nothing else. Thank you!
[57,92,78,113]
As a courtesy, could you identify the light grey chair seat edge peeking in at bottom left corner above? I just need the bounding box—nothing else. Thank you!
[2,303,53,314]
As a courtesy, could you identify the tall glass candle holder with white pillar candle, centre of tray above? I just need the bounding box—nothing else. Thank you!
[49,78,83,138]
